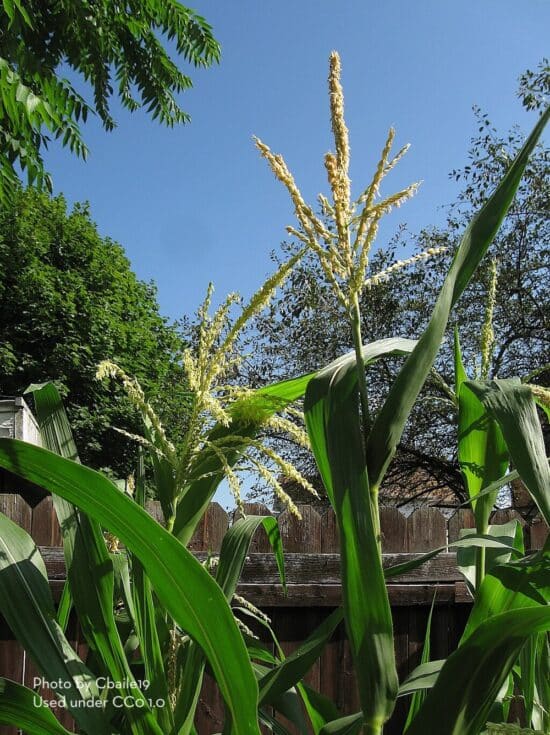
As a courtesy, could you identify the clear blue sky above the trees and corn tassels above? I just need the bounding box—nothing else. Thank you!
[46,0,550,318]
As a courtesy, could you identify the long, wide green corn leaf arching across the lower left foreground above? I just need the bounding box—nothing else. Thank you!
[0,439,264,735]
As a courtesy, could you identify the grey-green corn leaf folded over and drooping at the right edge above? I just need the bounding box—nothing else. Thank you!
[466,380,550,525]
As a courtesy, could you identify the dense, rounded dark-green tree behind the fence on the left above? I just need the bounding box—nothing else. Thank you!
[0,185,186,477]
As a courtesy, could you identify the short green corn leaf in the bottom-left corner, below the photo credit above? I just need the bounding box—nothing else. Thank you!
[0,679,71,735]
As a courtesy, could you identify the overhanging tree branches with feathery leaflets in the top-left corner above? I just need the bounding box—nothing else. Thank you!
[0,0,220,202]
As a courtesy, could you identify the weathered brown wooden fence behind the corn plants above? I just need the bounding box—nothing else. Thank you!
[0,493,548,735]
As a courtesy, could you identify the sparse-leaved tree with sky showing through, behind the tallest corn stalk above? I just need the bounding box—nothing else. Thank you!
[243,61,550,502]
